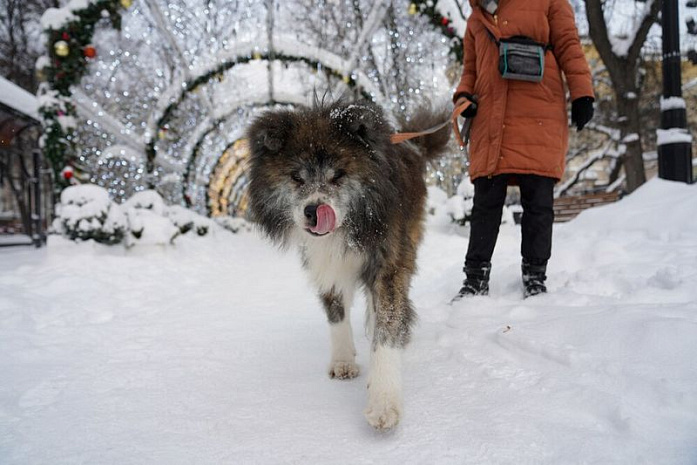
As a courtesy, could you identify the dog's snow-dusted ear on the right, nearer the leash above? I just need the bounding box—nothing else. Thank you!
[330,104,387,146]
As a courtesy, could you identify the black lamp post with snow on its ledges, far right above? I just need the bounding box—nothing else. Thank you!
[658,0,693,184]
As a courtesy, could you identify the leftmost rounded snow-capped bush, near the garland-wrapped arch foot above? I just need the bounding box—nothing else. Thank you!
[54,184,128,244]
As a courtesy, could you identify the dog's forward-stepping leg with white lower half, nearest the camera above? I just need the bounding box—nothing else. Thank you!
[365,271,415,431]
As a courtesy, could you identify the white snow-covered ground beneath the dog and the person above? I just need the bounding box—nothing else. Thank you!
[0,180,697,465]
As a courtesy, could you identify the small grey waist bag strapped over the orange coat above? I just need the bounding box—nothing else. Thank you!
[487,28,552,82]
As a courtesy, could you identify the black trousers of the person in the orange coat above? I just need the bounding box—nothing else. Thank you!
[465,174,556,267]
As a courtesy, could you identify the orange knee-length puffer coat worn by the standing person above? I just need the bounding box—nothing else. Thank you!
[453,0,594,180]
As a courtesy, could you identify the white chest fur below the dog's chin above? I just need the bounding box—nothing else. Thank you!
[303,234,365,292]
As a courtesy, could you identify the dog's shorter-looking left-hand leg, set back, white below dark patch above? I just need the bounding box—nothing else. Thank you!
[320,288,359,379]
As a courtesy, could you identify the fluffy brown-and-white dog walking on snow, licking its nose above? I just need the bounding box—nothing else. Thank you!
[247,102,449,430]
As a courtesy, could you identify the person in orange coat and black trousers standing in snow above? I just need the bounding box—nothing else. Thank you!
[453,0,595,301]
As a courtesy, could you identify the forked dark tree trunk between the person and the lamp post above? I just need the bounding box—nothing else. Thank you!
[585,0,661,192]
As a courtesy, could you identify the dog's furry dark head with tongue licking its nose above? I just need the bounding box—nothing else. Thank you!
[247,104,390,242]
